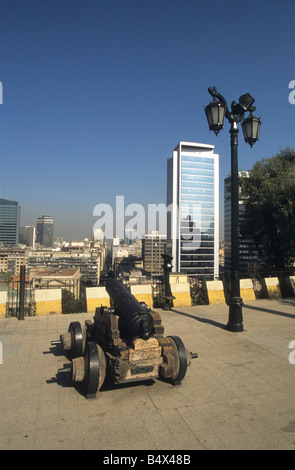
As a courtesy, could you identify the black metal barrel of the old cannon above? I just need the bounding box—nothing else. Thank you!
[106,279,154,340]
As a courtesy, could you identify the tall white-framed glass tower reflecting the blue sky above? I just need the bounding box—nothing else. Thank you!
[167,142,219,280]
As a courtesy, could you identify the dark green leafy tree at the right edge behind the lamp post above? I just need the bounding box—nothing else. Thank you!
[240,148,295,272]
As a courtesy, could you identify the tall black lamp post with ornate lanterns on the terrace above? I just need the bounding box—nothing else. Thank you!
[205,87,261,332]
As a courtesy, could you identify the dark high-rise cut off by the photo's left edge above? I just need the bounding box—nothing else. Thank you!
[0,199,20,246]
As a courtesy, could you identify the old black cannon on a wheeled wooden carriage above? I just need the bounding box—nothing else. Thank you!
[51,279,198,398]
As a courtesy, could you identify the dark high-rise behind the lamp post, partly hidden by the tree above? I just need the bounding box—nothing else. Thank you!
[224,171,257,275]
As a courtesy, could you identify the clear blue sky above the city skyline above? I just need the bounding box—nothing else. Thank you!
[0,0,295,239]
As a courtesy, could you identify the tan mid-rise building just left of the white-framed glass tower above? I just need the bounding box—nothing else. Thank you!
[142,230,167,276]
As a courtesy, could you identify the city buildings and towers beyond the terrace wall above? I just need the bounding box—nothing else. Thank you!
[0,142,255,288]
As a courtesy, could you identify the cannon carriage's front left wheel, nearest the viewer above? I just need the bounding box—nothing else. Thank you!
[84,341,106,398]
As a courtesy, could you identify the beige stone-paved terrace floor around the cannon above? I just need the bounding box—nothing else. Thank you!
[0,299,295,451]
